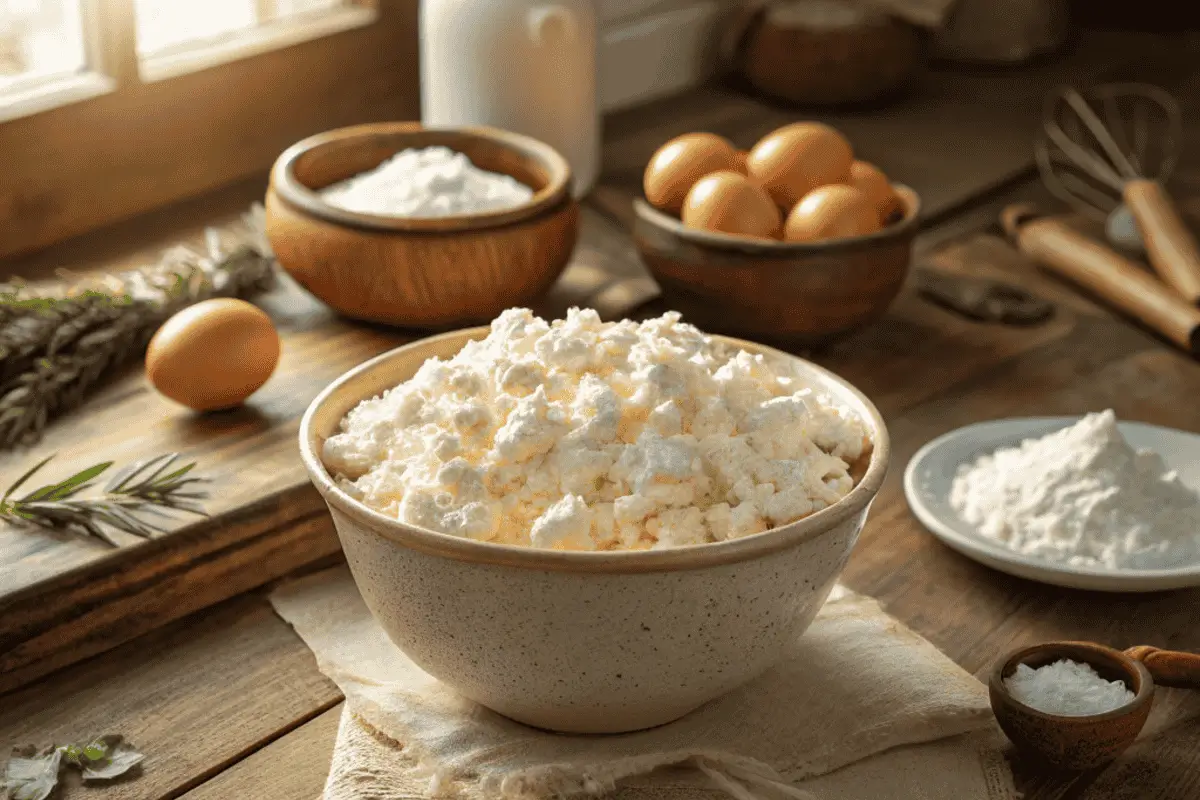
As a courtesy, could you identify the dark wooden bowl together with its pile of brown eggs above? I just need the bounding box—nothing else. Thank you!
[634,122,920,344]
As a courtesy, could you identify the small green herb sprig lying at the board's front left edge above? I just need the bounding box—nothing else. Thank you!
[0,453,208,547]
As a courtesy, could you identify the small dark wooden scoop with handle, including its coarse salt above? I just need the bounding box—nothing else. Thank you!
[988,642,1200,771]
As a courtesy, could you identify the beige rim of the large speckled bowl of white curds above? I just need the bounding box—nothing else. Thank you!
[300,326,890,573]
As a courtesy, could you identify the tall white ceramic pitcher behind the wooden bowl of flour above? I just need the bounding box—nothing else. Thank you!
[420,0,600,197]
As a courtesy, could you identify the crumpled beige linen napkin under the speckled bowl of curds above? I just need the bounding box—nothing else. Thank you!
[271,566,1015,800]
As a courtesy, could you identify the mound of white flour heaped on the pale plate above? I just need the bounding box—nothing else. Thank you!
[950,410,1200,570]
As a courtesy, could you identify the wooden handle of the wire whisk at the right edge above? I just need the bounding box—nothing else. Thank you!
[1123,180,1200,306]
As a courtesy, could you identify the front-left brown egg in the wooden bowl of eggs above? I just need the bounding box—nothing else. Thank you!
[680,170,781,239]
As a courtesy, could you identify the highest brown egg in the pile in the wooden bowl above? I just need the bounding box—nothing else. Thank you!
[746,122,854,209]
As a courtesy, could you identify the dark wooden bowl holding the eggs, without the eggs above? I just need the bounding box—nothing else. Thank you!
[634,185,920,345]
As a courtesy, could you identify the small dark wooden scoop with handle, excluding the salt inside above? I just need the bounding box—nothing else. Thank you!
[988,642,1200,771]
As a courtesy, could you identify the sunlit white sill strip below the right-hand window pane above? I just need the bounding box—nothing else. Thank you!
[139,6,379,83]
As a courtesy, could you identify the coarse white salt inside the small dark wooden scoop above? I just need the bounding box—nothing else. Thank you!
[1004,658,1135,717]
